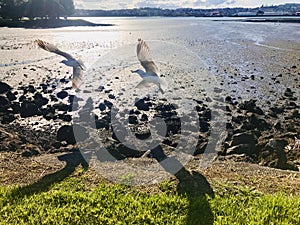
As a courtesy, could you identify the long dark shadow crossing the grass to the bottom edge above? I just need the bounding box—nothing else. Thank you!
[151,146,214,225]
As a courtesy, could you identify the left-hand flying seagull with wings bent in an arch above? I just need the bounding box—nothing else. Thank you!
[35,39,86,89]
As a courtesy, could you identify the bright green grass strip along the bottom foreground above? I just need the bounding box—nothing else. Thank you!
[0,177,300,225]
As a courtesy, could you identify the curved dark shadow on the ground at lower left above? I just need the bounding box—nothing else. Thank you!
[12,151,88,198]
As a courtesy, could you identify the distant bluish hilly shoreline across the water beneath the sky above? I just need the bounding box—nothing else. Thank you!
[73,4,300,17]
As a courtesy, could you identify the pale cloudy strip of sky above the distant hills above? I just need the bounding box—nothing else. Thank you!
[74,0,300,10]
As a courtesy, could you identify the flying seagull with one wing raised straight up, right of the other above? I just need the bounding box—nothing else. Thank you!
[131,38,165,94]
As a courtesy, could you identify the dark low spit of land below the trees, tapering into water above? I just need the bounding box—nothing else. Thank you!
[0,19,113,29]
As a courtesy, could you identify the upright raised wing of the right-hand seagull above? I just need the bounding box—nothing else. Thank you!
[136,38,158,76]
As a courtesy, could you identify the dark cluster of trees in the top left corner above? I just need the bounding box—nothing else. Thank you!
[0,0,75,20]
